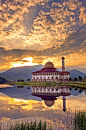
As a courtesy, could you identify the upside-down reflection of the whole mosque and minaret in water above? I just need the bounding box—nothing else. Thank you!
[32,86,71,112]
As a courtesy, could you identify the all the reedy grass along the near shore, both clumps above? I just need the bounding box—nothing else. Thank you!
[3,111,86,130]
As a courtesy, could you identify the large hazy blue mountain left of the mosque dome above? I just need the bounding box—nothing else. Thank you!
[0,65,43,81]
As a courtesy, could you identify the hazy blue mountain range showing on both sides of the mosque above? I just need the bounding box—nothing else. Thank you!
[0,65,86,81]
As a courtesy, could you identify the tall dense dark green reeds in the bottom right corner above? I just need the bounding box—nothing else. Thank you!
[74,111,86,130]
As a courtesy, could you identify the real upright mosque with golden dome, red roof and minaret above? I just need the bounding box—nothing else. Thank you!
[32,57,70,82]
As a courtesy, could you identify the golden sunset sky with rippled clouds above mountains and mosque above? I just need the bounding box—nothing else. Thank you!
[0,0,86,73]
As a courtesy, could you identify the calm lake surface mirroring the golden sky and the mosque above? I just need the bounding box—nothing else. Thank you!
[0,85,86,127]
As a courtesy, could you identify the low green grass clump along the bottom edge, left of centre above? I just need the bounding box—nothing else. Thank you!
[8,121,52,130]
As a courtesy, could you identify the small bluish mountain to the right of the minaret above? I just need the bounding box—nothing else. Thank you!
[69,69,86,78]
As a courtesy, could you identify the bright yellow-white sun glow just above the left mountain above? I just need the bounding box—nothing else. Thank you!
[12,57,37,67]
